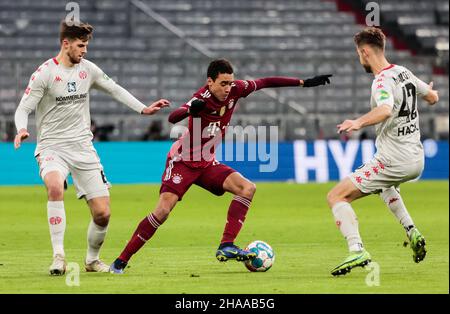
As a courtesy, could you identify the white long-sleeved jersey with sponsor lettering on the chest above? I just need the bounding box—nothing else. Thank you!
[15,58,145,155]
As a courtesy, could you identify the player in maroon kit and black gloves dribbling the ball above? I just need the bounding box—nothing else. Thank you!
[111,59,332,273]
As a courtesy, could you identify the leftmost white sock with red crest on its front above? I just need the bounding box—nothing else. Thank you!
[47,201,66,256]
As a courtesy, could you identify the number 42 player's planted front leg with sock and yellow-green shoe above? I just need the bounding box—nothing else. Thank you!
[327,178,371,276]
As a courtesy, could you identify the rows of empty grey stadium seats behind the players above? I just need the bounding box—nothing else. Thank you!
[0,0,449,140]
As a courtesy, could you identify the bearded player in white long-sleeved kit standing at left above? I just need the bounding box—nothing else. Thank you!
[14,22,169,275]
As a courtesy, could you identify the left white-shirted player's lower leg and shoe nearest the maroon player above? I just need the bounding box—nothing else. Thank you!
[85,196,111,273]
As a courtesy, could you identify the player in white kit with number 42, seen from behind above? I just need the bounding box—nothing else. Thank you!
[327,27,439,276]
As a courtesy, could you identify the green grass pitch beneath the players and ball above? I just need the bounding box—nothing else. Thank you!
[0,181,449,294]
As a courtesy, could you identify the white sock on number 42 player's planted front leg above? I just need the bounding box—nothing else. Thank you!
[332,202,363,252]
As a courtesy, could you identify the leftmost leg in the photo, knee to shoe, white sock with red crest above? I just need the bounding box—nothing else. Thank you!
[44,171,66,276]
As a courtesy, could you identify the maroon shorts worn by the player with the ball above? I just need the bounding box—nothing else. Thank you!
[159,157,236,201]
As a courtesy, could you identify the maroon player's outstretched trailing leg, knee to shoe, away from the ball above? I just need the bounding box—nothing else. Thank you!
[110,192,178,274]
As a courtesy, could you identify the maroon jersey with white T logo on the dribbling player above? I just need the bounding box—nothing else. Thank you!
[169,80,257,168]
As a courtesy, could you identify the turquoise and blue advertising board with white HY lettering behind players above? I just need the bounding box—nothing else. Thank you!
[0,140,449,185]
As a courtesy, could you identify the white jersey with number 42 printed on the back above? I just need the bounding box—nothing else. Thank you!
[370,64,430,165]
